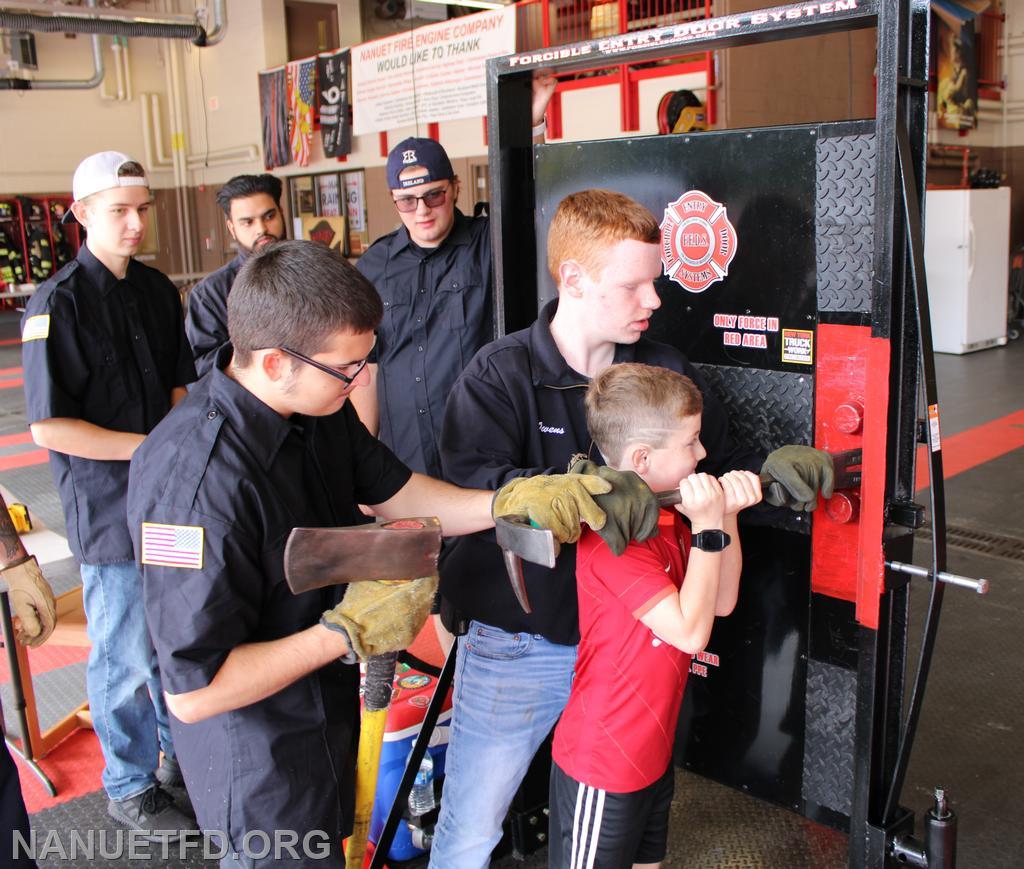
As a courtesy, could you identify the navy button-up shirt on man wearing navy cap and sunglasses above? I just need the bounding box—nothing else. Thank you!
[355,209,495,477]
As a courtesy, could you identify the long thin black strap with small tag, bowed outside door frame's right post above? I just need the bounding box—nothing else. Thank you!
[882,121,946,825]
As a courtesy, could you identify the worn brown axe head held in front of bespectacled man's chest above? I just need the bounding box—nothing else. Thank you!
[285,516,441,595]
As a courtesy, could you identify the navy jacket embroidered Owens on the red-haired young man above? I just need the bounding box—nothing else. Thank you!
[440,300,760,645]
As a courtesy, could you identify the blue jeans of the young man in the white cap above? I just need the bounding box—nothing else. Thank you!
[81,561,174,799]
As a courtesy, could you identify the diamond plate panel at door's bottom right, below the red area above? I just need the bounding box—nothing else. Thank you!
[803,660,857,815]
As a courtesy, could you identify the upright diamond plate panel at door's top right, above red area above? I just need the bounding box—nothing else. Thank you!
[815,134,874,312]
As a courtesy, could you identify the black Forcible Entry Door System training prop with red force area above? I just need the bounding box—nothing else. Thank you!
[479,0,983,869]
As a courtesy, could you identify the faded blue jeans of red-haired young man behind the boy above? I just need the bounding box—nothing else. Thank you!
[430,621,575,869]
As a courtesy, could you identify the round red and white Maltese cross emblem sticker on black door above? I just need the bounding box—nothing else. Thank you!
[662,190,736,293]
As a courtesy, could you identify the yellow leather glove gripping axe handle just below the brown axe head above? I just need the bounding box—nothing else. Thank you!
[321,576,437,663]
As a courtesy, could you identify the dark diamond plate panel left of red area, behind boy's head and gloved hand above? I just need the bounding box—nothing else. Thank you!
[694,362,814,534]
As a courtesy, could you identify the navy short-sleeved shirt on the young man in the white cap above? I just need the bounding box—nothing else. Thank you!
[22,245,196,564]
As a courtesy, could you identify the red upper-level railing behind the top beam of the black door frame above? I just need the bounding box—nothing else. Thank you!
[516,0,715,133]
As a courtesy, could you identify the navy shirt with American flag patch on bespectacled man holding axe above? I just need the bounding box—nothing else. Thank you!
[128,349,411,866]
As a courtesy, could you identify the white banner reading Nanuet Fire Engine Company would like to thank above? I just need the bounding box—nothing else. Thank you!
[352,6,515,135]
